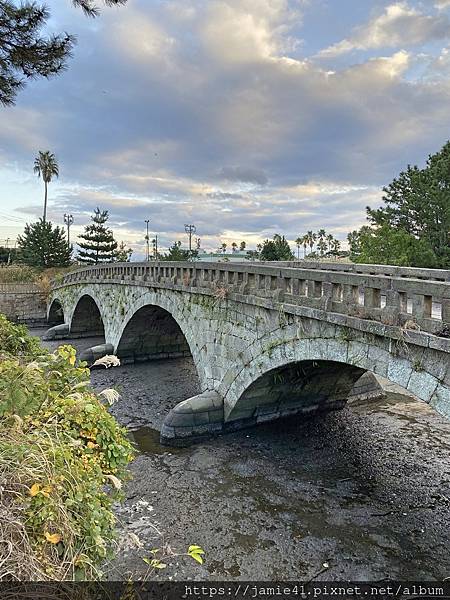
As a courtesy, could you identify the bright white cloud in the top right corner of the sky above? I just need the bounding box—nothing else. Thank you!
[318,0,450,58]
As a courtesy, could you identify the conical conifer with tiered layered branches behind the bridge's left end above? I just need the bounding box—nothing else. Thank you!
[78,207,117,265]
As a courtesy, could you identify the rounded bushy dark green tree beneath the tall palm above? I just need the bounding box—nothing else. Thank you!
[17,219,72,269]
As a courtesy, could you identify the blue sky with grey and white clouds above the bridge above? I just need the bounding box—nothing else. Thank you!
[0,0,450,258]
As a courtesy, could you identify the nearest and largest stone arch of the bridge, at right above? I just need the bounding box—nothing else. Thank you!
[218,328,449,422]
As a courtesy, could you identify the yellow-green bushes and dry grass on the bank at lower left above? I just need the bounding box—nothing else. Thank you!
[0,318,133,579]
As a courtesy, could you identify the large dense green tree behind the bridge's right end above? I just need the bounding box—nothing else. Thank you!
[349,142,450,268]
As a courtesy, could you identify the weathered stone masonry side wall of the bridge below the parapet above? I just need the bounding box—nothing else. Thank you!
[52,281,450,421]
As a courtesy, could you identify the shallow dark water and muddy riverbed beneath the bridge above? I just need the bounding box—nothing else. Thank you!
[33,328,450,581]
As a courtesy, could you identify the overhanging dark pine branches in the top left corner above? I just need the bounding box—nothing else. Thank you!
[0,0,126,106]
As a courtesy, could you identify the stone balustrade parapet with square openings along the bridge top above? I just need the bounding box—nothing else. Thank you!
[51,261,450,334]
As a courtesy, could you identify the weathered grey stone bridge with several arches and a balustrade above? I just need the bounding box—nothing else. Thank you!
[48,262,450,444]
